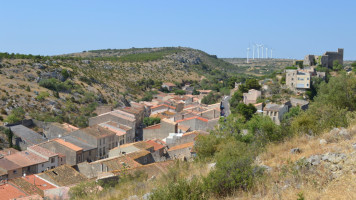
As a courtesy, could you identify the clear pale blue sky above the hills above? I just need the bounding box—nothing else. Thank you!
[0,0,356,60]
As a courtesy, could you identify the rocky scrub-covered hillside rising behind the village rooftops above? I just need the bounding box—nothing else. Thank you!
[0,47,243,127]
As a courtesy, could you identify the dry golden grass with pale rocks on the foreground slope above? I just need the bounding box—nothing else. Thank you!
[231,126,356,200]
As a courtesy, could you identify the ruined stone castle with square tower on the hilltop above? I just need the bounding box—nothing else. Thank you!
[303,48,344,68]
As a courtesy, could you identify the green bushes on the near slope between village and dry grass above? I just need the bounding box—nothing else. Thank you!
[147,73,356,199]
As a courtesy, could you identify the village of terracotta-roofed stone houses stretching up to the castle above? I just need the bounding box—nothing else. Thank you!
[0,49,343,199]
